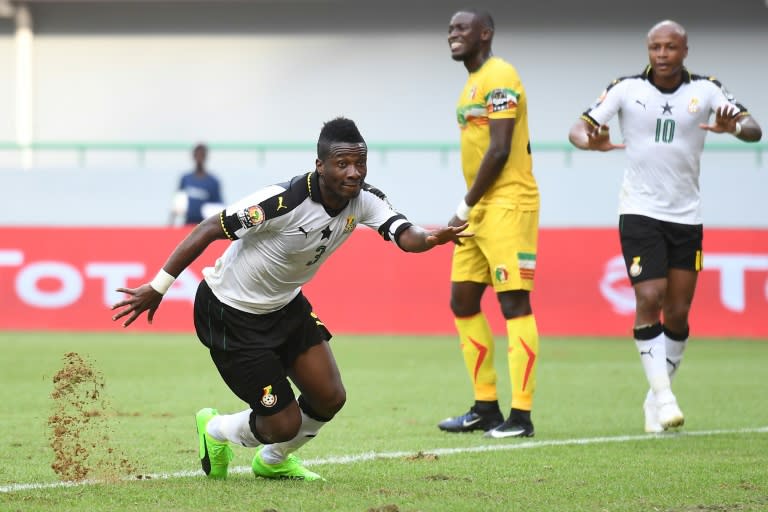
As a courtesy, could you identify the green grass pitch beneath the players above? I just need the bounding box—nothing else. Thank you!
[0,331,768,512]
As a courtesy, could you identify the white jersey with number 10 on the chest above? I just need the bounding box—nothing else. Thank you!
[582,66,746,224]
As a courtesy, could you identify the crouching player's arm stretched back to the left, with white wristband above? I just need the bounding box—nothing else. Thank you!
[112,215,226,327]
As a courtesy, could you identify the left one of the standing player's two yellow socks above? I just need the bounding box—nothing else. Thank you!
[455,313,498,402]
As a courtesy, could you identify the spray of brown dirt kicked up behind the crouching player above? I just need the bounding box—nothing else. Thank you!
[48,352,135,481]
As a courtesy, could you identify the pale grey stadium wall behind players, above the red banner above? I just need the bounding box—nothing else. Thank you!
[0,0,768,228]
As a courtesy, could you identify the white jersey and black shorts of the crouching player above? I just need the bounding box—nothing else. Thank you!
[195,171,412,415]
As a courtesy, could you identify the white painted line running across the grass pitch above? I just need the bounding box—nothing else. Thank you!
[0,427,768,492]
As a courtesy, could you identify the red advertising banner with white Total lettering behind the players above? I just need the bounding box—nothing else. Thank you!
[0,228,768,338]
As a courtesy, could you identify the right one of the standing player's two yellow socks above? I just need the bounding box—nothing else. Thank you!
[507,315,539,411]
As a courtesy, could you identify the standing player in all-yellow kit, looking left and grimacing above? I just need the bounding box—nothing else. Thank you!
[438,9,539,438]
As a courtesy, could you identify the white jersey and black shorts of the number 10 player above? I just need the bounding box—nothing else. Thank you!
[582,66,747,284]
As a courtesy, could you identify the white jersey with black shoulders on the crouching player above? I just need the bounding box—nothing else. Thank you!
[203,171,411,314]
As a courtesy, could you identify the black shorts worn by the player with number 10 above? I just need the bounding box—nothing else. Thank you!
[619,214,704,285]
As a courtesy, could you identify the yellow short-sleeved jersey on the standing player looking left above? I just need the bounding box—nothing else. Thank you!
[456,57,539,210]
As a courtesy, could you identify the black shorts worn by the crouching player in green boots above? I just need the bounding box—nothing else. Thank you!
[194,280,331,416]
